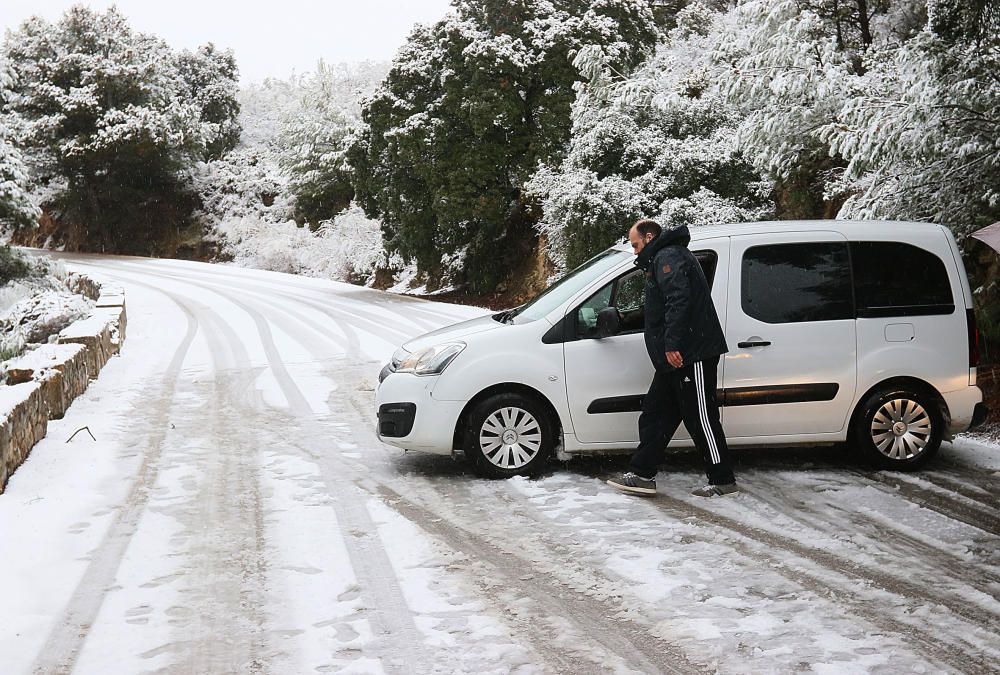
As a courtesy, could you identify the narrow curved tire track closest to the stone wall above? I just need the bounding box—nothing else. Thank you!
[32,280,198,675]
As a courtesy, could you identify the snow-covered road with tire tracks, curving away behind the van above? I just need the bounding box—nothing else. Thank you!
[0,256,1000,675]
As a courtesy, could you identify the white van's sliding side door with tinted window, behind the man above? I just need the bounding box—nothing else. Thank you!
[722,232,857,438]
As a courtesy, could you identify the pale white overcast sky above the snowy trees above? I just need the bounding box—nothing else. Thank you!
[0,0,450,84]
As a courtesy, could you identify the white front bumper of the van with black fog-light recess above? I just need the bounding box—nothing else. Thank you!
[375,372,464,455]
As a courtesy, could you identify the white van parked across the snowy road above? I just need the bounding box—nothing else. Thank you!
[376,221,987,477]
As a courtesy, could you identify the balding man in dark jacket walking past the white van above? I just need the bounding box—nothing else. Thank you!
[608,220,739,497]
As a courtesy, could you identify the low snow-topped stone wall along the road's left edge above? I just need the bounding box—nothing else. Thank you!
[0,274,126,494]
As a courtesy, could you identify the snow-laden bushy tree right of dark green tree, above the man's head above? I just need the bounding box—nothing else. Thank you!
[530,2,770,267]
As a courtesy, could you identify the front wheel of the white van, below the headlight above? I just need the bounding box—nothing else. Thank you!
[462,394,556,478]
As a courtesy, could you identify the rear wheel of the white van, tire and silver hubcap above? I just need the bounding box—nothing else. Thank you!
[851,387,944,471]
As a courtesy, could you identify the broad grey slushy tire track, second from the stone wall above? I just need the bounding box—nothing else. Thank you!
[166,306,267,673]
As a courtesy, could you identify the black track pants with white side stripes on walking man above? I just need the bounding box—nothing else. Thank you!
[630,357,735,485]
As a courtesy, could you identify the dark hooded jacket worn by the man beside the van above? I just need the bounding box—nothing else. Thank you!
[635,225,729,370]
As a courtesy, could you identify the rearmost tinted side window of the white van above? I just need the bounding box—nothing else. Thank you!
[850,241,955,318]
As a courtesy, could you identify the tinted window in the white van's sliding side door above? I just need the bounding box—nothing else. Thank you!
[741,242,854,323]
